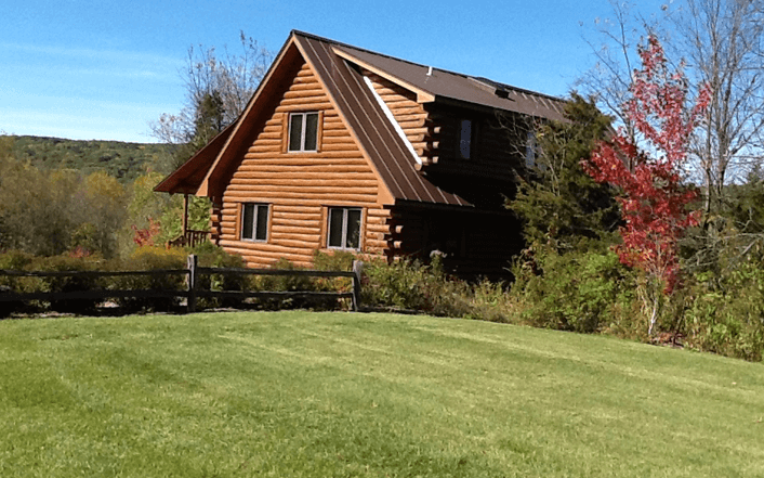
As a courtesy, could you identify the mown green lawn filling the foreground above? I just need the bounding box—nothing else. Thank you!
[0,311,764,478]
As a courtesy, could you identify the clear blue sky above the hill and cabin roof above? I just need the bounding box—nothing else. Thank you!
[0,0,667,142]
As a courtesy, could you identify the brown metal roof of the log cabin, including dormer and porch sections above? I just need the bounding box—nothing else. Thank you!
[156,31,565,206]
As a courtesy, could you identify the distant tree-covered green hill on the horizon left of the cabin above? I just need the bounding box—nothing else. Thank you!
[7,136,174,183]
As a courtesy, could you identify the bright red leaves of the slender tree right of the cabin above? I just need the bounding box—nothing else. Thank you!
[583,36,711,294]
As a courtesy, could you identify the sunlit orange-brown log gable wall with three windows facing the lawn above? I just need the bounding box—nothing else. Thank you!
[220,64,388,267]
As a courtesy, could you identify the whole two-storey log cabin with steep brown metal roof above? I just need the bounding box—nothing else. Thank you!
[155,31,565,277]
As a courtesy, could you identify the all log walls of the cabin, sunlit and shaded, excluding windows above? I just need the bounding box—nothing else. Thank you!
[213,58,519,276]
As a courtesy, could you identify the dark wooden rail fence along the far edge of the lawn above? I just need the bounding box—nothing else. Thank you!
[0,255,363,312]
